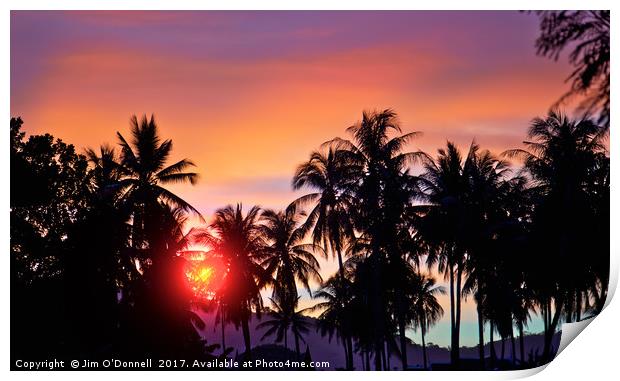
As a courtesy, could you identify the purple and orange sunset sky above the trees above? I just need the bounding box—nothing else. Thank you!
[11,11,570,345]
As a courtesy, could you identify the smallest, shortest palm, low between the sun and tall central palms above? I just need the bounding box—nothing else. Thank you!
[257,296,311,359]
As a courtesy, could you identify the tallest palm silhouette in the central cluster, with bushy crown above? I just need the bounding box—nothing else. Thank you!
[327,109,423,369]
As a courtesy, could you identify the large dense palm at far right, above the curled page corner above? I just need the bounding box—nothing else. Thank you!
[505,110,609,360]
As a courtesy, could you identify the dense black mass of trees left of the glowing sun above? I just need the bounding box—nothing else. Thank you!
[11,118,213,366]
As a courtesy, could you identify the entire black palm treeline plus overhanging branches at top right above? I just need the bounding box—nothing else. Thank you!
[10,11,610,370]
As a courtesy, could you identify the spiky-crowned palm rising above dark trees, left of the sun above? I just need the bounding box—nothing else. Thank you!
[117,115,200,258]
